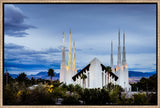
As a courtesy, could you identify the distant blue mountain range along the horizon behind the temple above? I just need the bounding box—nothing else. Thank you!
[4,70,156,80]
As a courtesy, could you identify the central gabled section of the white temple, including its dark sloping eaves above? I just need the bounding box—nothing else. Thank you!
[72,58,118,88]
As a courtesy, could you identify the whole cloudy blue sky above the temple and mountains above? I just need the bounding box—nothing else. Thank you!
[4,4,156,74]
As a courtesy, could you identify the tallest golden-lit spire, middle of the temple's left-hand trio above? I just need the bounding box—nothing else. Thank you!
[68,29,72,69]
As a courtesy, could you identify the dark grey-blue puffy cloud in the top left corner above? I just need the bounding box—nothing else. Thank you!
[4,4,36,37]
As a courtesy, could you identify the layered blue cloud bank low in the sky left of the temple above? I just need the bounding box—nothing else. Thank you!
[4,43,61,72]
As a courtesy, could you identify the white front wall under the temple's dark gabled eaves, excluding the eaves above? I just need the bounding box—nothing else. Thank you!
[75,58,116,88]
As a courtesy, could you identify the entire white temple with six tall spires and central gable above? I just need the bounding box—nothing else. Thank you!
[60,30,131,91]
